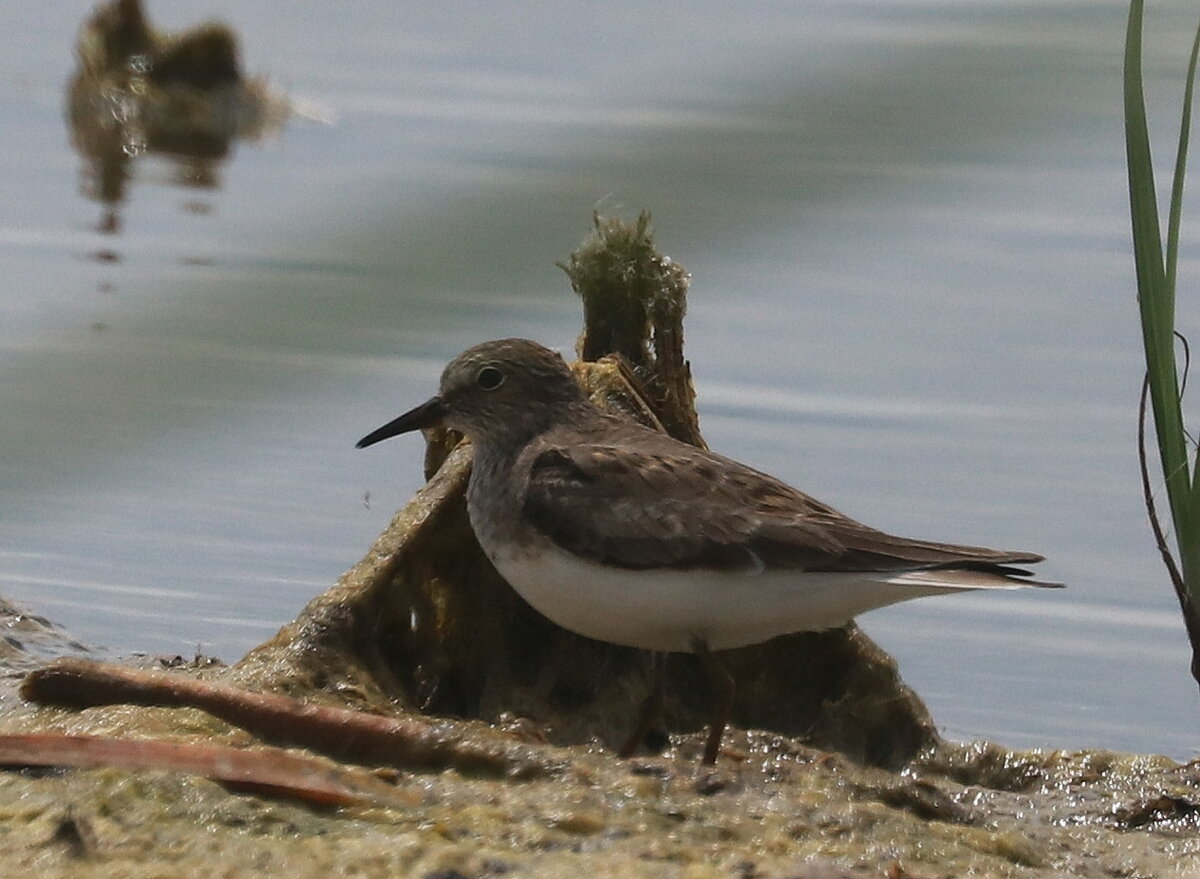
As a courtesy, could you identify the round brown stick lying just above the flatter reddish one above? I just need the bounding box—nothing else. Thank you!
[20,659,551,775]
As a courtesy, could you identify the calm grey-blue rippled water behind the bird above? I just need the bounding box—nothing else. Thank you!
[0,0,1200,758]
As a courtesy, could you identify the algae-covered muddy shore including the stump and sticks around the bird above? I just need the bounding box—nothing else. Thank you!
[7,214,1200,879]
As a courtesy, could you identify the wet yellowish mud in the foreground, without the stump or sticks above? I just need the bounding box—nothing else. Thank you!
[0,670,1200,879]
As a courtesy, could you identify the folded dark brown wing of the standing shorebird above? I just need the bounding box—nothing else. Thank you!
[523,431,1040,576]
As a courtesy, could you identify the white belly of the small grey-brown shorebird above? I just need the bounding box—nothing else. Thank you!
[488,543,961,652]
